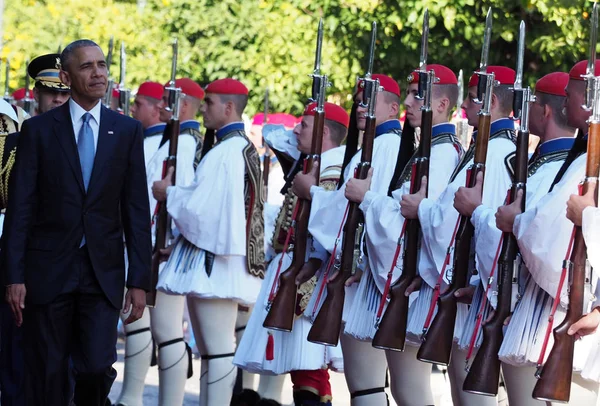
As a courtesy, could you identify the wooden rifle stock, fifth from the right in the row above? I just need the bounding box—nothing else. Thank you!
[308,117,375,346]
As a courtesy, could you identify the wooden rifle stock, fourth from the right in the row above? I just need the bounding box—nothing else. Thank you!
[373,110,433,351]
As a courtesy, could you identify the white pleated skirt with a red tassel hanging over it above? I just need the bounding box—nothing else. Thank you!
[233,254,344,375]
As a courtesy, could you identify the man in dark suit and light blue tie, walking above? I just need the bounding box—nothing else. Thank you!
[4,40,151,406]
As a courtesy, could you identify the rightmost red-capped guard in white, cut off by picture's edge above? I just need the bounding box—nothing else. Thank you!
[499,61,600,404]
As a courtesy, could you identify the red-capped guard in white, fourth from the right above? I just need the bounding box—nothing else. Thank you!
[345,61,463,405]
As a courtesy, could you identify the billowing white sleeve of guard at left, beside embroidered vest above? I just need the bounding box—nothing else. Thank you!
[167,137,247,255]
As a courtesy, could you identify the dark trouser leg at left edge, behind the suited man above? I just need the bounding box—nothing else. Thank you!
[0,299,25,406]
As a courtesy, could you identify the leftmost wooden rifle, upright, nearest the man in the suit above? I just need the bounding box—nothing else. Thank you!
[146,120,179,307]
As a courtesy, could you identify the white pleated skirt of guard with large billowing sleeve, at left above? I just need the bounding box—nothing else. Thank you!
[157,236,262,305]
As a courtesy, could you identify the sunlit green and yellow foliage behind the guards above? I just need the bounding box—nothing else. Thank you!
[1,0,591,114]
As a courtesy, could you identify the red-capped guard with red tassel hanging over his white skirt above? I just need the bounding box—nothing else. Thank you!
[234,103,350,406]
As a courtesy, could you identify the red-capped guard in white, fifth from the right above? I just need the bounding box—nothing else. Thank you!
[293,69,414,406]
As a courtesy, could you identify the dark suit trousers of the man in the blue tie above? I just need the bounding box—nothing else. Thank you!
[23,247,119,406]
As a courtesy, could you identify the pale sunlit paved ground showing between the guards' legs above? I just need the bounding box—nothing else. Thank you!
[110,340,452,406]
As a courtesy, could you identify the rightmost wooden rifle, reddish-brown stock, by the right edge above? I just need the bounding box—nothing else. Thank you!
[533,122,600,402]
